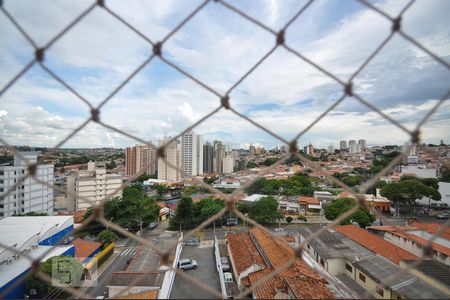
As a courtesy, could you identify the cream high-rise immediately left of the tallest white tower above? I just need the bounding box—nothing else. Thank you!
[158,138,181,182]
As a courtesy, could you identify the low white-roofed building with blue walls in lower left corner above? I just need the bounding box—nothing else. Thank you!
[0,216,75,299]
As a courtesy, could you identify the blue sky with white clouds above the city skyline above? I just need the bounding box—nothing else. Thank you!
[0,0,450,147]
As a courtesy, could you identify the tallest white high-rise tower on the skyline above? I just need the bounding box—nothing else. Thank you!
[181,130,203,178]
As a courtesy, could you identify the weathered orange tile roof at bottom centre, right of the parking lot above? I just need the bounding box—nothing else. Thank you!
[227,227,335,299]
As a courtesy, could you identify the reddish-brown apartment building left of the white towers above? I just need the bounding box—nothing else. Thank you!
[125,145,156,175]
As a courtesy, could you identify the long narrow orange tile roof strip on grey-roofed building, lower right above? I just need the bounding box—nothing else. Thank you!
[334,225,419,265]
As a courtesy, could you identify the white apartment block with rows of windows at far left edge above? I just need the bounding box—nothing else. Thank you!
[0,152,54,219]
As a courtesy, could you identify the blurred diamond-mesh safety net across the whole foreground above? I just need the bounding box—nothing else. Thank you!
[0,0,450,298]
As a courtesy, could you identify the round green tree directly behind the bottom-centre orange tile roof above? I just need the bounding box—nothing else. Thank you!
[248,196,283,225]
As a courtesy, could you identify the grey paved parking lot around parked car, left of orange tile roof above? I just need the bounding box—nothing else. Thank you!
[170,246,220,299]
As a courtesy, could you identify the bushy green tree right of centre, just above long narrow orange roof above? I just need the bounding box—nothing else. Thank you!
[324,198,375,228]
